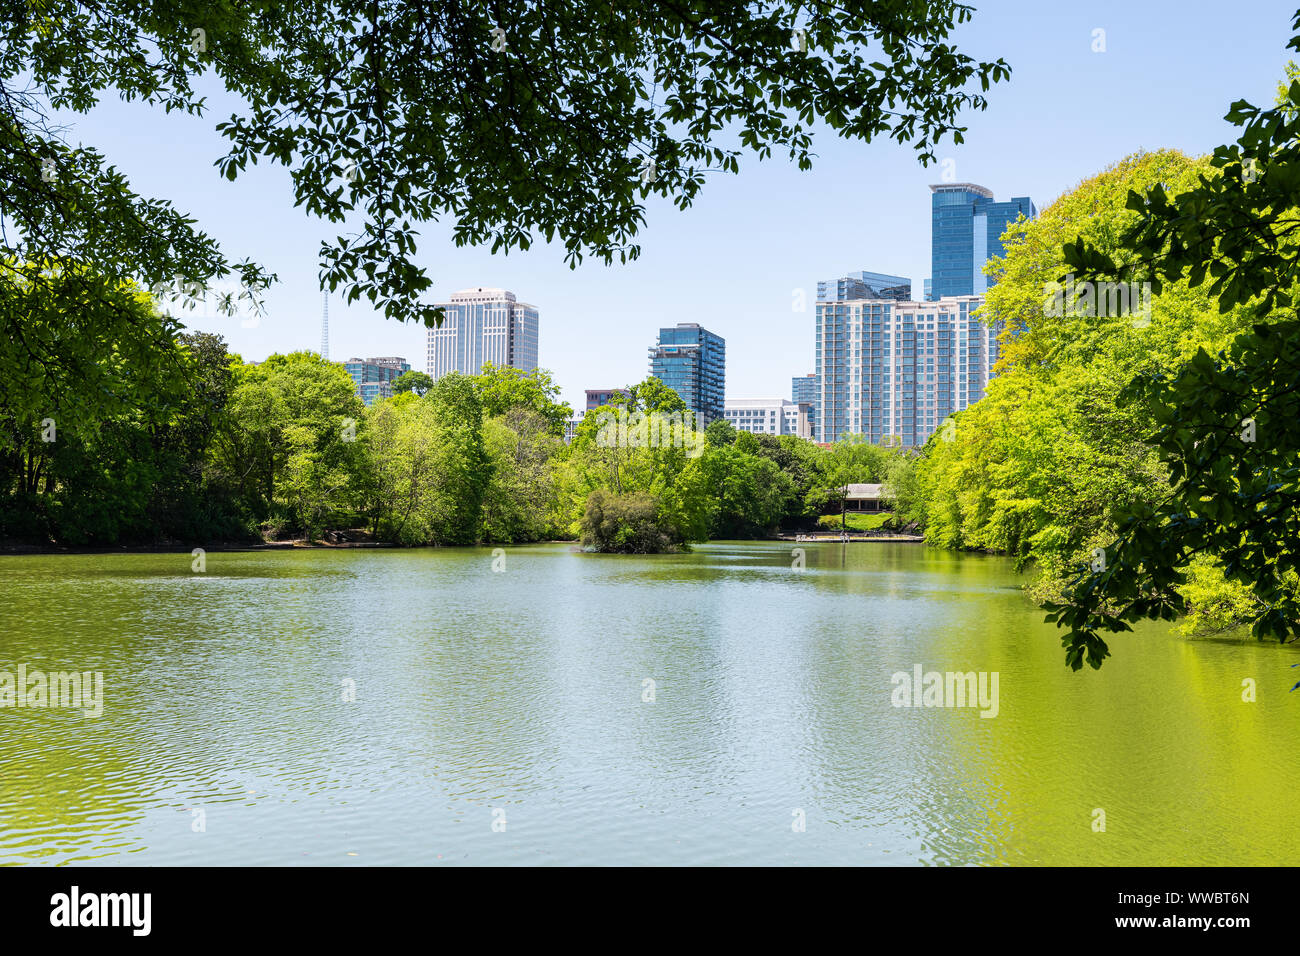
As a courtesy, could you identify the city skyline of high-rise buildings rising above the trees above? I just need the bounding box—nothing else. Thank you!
[379,171,1037,447]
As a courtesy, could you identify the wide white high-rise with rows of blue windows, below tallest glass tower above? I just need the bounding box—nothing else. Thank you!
[816,295,1000,447]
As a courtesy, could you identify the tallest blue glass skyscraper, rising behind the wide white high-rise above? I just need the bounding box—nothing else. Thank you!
[930,182,1037,302]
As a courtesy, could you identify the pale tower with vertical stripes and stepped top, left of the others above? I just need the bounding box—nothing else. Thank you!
[428,287,537,380]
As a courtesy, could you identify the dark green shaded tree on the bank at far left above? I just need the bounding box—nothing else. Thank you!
[0,264,244,545]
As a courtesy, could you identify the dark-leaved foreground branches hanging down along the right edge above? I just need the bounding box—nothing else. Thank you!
[1048,12,1300,671]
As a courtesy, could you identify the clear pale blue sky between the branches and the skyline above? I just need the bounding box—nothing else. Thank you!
[55,0,1300,408]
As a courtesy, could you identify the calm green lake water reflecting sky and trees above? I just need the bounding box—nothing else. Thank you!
[0,542,1300,865]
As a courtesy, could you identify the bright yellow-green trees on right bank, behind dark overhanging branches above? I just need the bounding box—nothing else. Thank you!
[889,143,1295,666]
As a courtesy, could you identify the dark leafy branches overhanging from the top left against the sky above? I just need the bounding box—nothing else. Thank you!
[0,0,1010,335]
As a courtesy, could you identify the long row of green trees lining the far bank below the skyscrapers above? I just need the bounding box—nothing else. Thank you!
[0,271,893,551]
